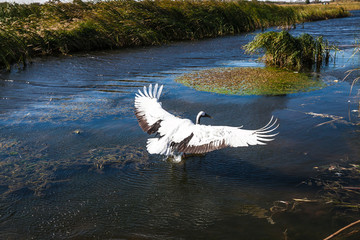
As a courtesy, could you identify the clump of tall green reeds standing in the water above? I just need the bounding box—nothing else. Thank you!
[245,31,335,71]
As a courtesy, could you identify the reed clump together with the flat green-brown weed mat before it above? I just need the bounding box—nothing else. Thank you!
[176,31,335,95]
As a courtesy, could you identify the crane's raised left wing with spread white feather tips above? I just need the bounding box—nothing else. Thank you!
[135,84,176,134]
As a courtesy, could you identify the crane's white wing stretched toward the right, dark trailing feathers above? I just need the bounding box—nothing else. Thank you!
[172,117,279,154]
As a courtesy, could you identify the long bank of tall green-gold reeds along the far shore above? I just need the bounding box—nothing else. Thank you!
[0,0,349,69]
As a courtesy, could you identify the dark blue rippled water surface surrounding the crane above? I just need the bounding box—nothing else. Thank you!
[0,12,360,239]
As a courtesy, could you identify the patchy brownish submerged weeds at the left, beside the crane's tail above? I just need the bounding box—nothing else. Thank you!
[0,136,148,197]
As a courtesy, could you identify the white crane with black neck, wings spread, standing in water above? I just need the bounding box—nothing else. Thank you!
[135,84,279,162]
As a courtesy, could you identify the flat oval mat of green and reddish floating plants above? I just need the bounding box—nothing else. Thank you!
[176,67,324,95]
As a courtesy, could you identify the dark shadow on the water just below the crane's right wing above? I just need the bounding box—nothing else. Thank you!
[168,150,310,197]
